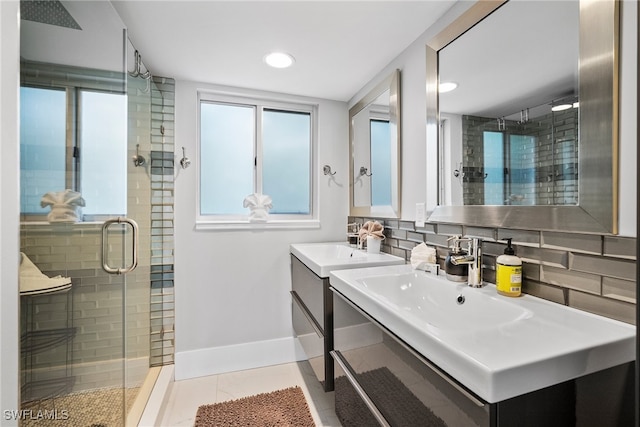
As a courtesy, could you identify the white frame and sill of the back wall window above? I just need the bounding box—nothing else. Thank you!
[195,90,320,230]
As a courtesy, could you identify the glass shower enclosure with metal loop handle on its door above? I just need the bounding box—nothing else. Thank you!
[20,1,151,426]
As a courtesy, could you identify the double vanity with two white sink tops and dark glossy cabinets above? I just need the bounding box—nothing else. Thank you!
[290,243,636,426]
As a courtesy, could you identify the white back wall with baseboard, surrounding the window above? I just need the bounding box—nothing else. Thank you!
[175,81,349,379]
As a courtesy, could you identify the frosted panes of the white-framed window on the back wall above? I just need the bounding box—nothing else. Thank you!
[199,94,314,227]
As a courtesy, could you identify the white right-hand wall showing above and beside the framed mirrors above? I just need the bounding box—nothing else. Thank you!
[348,0,638,237]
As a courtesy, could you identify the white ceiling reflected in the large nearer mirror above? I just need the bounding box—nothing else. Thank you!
[438,0,580,120]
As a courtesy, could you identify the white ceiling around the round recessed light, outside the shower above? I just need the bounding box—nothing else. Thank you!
[112,0,454,101]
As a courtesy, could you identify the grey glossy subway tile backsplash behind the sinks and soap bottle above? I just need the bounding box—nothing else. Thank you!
[348,217,636,324]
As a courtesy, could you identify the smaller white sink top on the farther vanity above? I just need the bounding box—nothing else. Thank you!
[290,242,405,278]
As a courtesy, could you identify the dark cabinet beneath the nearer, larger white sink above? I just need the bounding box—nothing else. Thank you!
[331,288,633,427]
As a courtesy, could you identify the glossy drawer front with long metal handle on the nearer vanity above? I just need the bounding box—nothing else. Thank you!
[331,290,491,426]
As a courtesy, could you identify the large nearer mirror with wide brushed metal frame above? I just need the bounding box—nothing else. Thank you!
[427,0,619,234]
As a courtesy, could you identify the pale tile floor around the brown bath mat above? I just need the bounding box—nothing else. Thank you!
[161,362,341,427]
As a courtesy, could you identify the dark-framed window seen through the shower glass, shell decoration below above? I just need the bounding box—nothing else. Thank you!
[20,86,127,217]
